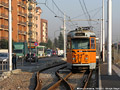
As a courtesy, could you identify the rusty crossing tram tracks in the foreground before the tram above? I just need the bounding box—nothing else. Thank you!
[35,63,93,90]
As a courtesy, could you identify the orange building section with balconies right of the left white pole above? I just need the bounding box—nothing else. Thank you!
[12,0,27,42]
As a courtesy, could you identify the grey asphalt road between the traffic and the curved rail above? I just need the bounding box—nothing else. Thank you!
[17,56,63,72]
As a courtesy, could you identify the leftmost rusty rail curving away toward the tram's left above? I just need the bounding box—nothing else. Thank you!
[35,62,66,90]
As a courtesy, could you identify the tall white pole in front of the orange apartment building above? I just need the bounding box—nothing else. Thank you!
[8,0,12,71]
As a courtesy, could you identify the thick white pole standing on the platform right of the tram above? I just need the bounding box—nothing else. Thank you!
[107,0,112,75]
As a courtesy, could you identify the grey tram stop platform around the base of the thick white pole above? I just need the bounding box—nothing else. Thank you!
[99,63,120,90]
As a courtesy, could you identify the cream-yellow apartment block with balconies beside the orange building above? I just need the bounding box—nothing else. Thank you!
[27,0,37,45]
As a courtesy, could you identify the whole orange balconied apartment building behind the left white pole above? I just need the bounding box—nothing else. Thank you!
[0,0,27,42]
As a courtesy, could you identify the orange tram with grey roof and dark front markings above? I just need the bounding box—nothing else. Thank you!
[67,27,96,69]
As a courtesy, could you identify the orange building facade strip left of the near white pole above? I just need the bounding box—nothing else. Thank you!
[0,0,9,40]
